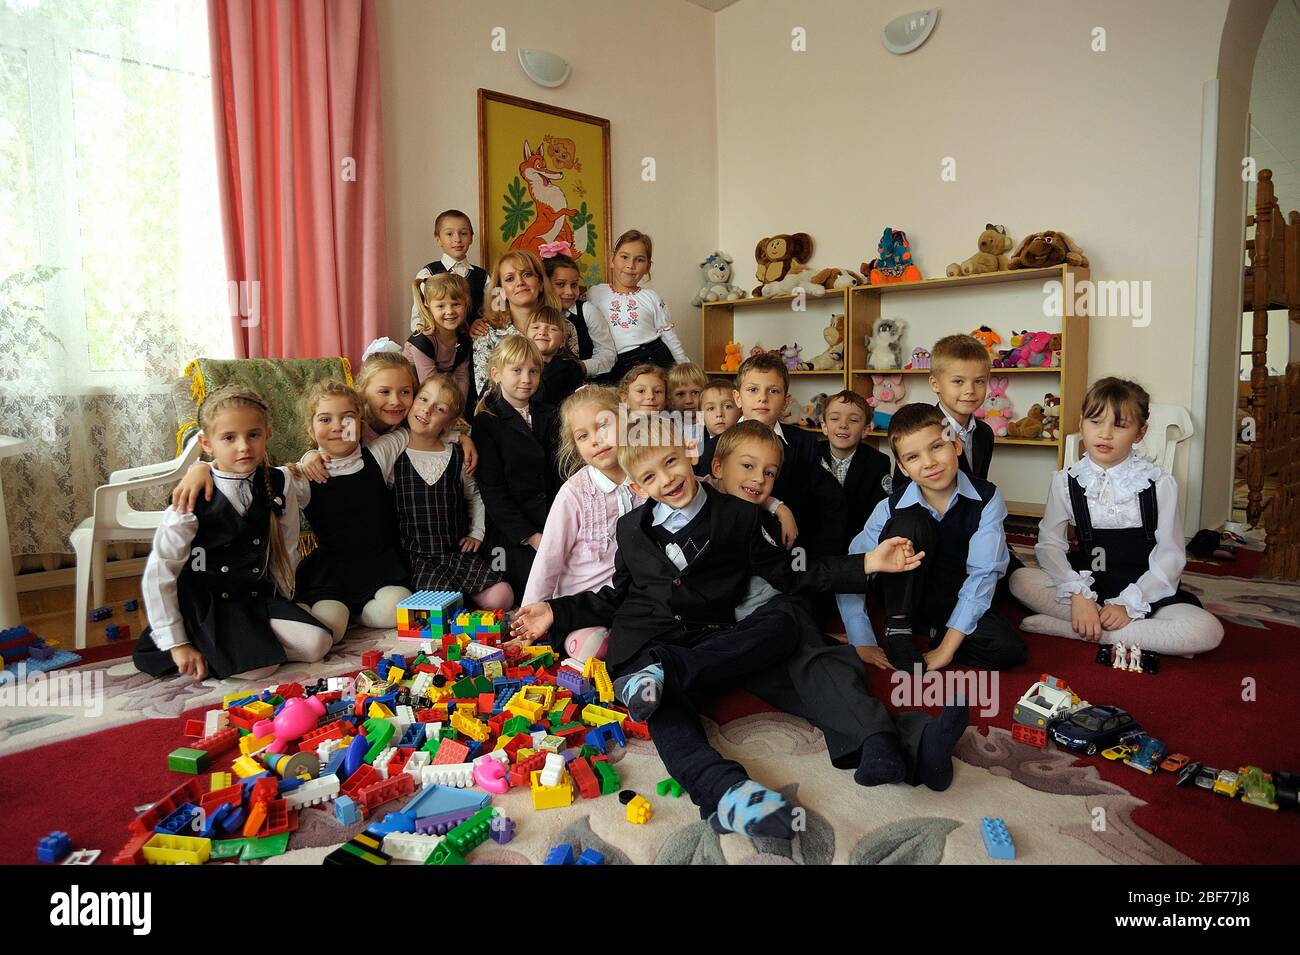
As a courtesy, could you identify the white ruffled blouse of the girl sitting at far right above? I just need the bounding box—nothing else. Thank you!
[1034,451,1187,620]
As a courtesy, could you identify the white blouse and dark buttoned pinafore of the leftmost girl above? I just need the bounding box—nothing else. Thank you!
[133,465,324,680]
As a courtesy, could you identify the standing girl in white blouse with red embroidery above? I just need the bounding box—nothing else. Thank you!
[586,229,689,381]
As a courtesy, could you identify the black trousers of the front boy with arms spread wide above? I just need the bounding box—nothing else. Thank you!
[615,604,800,816]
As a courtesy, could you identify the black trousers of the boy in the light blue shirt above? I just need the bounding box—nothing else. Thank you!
[875,507,1030,670]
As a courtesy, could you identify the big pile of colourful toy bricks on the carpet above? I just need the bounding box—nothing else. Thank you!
[96,617,660,864]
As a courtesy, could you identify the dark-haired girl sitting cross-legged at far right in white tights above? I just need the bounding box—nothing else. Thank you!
[1010,378,1223,656]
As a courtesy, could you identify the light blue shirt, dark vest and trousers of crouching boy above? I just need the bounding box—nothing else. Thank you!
[837,472,1028,670]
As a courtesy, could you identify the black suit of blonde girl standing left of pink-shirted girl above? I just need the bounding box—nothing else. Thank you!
[475,392,562,594]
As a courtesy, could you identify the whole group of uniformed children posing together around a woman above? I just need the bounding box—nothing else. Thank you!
[135,210,1222,837]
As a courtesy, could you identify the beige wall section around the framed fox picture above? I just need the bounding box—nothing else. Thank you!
[377,0,718,356]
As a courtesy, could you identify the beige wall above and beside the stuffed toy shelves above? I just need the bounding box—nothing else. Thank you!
[716,0,1229,509]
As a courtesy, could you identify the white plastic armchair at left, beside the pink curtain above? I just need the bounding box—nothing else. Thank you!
[69,435,199,650]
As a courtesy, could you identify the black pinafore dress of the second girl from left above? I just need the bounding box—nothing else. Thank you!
[295,446,410,615]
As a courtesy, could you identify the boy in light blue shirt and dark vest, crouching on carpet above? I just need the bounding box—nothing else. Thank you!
[837,403,1028,670]
